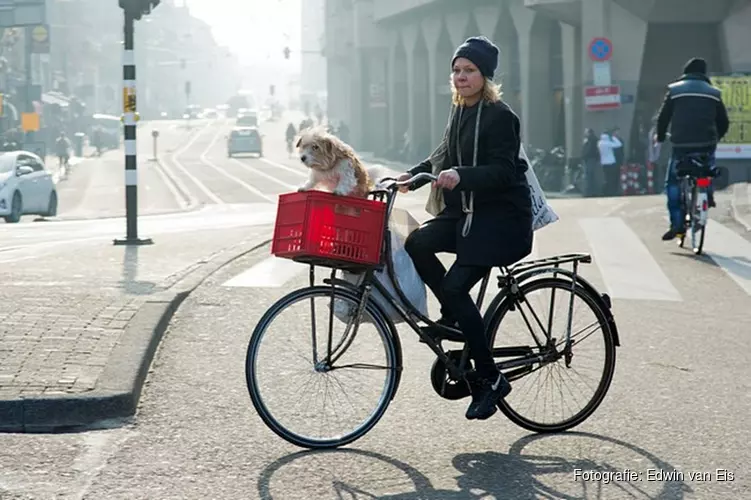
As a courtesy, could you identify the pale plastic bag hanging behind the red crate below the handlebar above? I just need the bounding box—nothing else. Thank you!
[334,208,428,323]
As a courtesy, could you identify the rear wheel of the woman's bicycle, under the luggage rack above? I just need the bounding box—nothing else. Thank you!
[488,277,615,433]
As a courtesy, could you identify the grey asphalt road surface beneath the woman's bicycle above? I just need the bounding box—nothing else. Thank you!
[0,113,751,500]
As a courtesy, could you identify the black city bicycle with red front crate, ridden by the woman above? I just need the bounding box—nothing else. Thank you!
[245,174,620,449]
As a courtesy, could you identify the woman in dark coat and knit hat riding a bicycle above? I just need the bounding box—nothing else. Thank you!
[399,37,532,420]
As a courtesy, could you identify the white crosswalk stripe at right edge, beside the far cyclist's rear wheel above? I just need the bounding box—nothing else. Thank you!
[704,220,751,295]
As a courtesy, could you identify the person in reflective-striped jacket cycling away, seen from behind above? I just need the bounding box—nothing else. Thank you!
[654,58,730,241]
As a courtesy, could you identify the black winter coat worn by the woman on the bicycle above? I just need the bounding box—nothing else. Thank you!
[409,101,533,267]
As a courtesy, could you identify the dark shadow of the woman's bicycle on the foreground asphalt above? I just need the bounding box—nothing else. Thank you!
[258,432,693,500]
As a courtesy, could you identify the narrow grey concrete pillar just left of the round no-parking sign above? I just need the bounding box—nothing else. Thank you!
[561,23,584,157]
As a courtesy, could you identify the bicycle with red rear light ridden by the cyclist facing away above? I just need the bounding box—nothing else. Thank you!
[676,154,719,255]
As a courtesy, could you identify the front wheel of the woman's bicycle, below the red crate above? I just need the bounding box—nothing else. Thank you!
[245,286,401,449]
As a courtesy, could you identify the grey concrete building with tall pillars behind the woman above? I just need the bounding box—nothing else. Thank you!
[326,0,751,164]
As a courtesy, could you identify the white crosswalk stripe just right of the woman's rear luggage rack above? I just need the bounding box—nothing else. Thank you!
[579,217,683,302]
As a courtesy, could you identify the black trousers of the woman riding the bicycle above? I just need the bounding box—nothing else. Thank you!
[405,219,496,376]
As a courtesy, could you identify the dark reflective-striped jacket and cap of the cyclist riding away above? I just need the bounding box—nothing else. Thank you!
[657,59,730,153]
